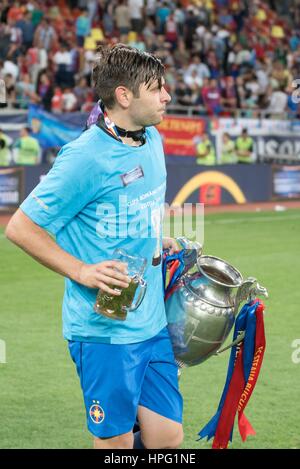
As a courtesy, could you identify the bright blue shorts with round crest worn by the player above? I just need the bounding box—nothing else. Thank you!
[69,328,183,438]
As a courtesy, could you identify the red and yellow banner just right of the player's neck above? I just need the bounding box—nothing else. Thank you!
[157,116,205,156]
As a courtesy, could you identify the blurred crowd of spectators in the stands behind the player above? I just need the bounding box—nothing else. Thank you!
[0,0,300,117]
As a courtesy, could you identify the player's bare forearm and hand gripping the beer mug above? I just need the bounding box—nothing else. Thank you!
[5,209,130,295]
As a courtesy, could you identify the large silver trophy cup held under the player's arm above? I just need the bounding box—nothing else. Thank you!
[165,240,268,368]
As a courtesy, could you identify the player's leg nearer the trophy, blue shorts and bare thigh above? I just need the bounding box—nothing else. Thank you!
[134,329,183,449]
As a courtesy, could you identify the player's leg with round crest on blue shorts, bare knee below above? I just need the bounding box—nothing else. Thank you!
[69,341,151,449]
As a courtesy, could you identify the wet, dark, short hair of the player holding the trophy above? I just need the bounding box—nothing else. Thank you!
[92,44,164,109]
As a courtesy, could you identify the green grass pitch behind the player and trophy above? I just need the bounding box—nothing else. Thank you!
[0,210,300,449]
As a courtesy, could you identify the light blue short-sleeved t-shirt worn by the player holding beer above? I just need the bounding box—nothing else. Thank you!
[20,125,166,344]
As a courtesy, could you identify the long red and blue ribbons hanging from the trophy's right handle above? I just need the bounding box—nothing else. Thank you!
[198,299,266,449]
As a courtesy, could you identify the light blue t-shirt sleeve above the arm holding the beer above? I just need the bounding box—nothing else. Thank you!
[20,145,101,235]
